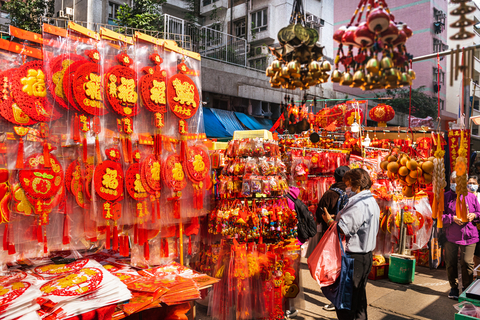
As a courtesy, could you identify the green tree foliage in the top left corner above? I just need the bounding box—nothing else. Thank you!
[2,0,55,33]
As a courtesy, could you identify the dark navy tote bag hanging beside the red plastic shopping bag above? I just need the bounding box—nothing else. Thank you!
[322,226,355,310]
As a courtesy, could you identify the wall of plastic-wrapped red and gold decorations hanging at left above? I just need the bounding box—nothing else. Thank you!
[0,23,208,265]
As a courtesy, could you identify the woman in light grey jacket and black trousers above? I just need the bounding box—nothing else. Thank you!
[323,168,380,320]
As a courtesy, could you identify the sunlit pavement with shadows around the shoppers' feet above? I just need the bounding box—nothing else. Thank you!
[196,259,458,320]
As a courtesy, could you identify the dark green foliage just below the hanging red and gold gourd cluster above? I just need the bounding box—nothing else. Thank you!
[376,86,438,120]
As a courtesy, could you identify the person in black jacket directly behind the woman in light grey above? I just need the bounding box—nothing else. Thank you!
[307,166,350,311]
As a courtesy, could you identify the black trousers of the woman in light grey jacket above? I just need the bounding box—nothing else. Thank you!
[336,252,373,320]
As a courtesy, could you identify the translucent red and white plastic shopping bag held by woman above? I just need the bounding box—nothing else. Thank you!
[308,222,342,287]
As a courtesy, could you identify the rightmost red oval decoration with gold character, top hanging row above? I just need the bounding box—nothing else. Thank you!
[167,74,200,119]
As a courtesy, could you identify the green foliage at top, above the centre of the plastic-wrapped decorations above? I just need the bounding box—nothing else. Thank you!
[115,0,167,31]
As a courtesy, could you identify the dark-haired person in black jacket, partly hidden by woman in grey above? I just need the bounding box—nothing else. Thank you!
[314,166,350,311]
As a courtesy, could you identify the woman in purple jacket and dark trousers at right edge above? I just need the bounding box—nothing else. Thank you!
[443,171,480,299]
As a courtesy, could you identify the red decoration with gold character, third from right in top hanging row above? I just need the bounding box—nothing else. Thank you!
[104,53,139,117]
